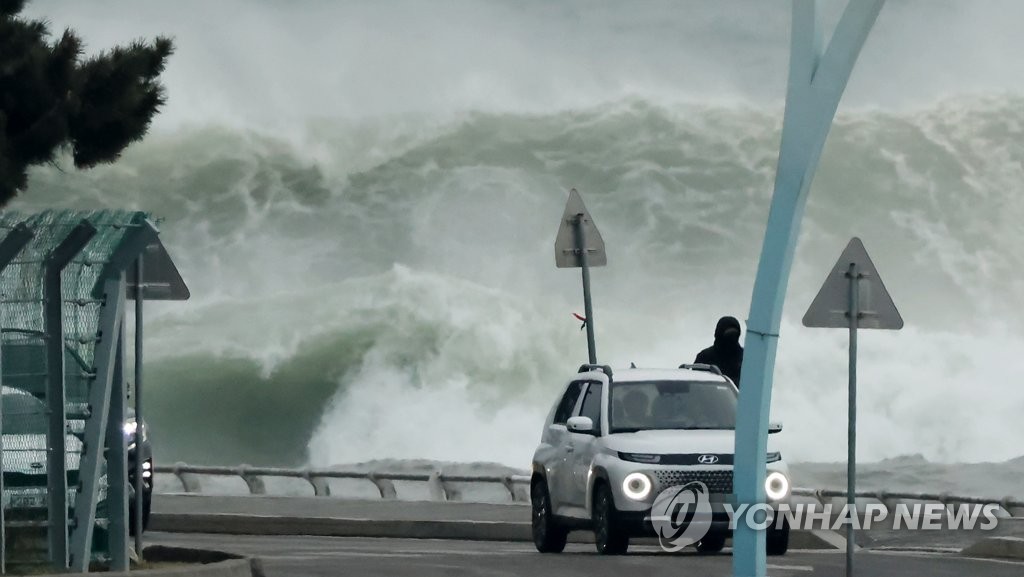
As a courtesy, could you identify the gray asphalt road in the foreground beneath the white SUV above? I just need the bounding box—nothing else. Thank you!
[147,533,1024,577]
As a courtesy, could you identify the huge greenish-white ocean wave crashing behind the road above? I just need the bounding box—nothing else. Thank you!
[16,95,1024,473]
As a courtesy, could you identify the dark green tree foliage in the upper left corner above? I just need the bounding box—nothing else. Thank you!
[0,0,174,206]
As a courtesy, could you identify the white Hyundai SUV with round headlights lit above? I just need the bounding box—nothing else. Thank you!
[530,365,791,554]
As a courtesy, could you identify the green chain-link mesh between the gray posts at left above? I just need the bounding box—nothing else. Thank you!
[0,210,146,569]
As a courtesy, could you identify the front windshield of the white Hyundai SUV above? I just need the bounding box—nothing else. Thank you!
[608,380,736,432]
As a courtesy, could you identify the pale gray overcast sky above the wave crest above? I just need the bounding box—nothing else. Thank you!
[22,0,1024,125]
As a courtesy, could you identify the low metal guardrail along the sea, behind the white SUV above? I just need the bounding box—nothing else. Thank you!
[155,463,1024,516]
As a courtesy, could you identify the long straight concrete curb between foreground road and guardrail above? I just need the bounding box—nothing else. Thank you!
[150,511,845,549]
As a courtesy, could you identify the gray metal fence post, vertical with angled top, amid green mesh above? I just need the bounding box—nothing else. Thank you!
[43,220,96,569]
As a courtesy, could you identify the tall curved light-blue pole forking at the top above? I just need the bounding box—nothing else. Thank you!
[732,0,885,577]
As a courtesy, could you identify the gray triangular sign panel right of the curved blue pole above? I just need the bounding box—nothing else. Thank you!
[804,237,903,330]
